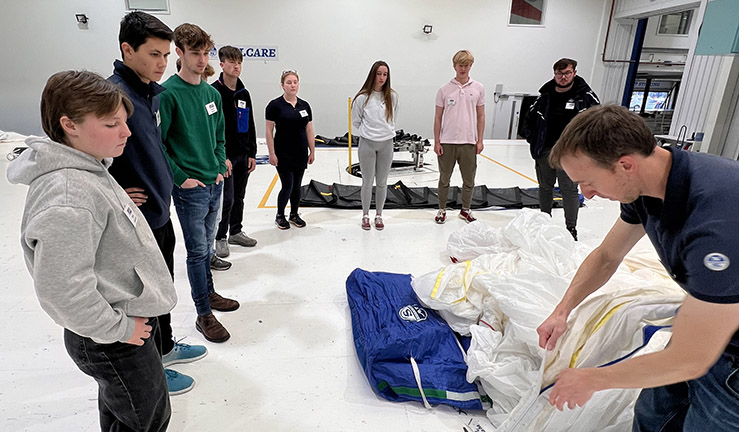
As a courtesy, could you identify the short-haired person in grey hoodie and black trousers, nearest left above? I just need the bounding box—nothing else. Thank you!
[7,71,177,431]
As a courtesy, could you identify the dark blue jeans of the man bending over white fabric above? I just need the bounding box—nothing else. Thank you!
[632,353,739,432]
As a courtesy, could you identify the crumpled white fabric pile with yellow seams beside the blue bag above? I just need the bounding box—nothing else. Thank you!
[413,210,684,432]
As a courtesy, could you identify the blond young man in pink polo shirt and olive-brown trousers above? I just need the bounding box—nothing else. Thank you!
[434,50,485,224]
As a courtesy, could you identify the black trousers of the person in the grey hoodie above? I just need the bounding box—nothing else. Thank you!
[64,318,172,432]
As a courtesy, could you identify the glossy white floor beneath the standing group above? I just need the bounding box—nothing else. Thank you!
[0,141,618,432]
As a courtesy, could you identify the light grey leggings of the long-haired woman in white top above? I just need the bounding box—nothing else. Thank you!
[359,137,393,215]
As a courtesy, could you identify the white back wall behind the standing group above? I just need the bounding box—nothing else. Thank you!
[0,0,610,137]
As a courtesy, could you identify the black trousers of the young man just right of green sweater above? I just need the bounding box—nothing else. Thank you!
[216,155,249,240]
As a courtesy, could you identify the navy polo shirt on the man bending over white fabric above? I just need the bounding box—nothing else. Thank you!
[621,148,739,352]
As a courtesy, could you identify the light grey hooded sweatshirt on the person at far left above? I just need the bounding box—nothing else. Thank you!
[7,137,177,343]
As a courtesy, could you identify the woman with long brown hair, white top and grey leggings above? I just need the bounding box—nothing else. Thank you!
[352,60,398,230]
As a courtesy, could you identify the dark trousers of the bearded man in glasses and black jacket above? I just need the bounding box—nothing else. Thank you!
[534,150,580,228]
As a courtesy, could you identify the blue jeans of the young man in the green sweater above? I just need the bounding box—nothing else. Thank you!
[172,182,223,315]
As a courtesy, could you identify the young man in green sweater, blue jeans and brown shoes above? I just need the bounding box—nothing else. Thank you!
[160,24,239,342]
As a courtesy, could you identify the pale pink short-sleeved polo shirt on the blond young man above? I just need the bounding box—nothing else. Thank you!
[436,78,485,144]
